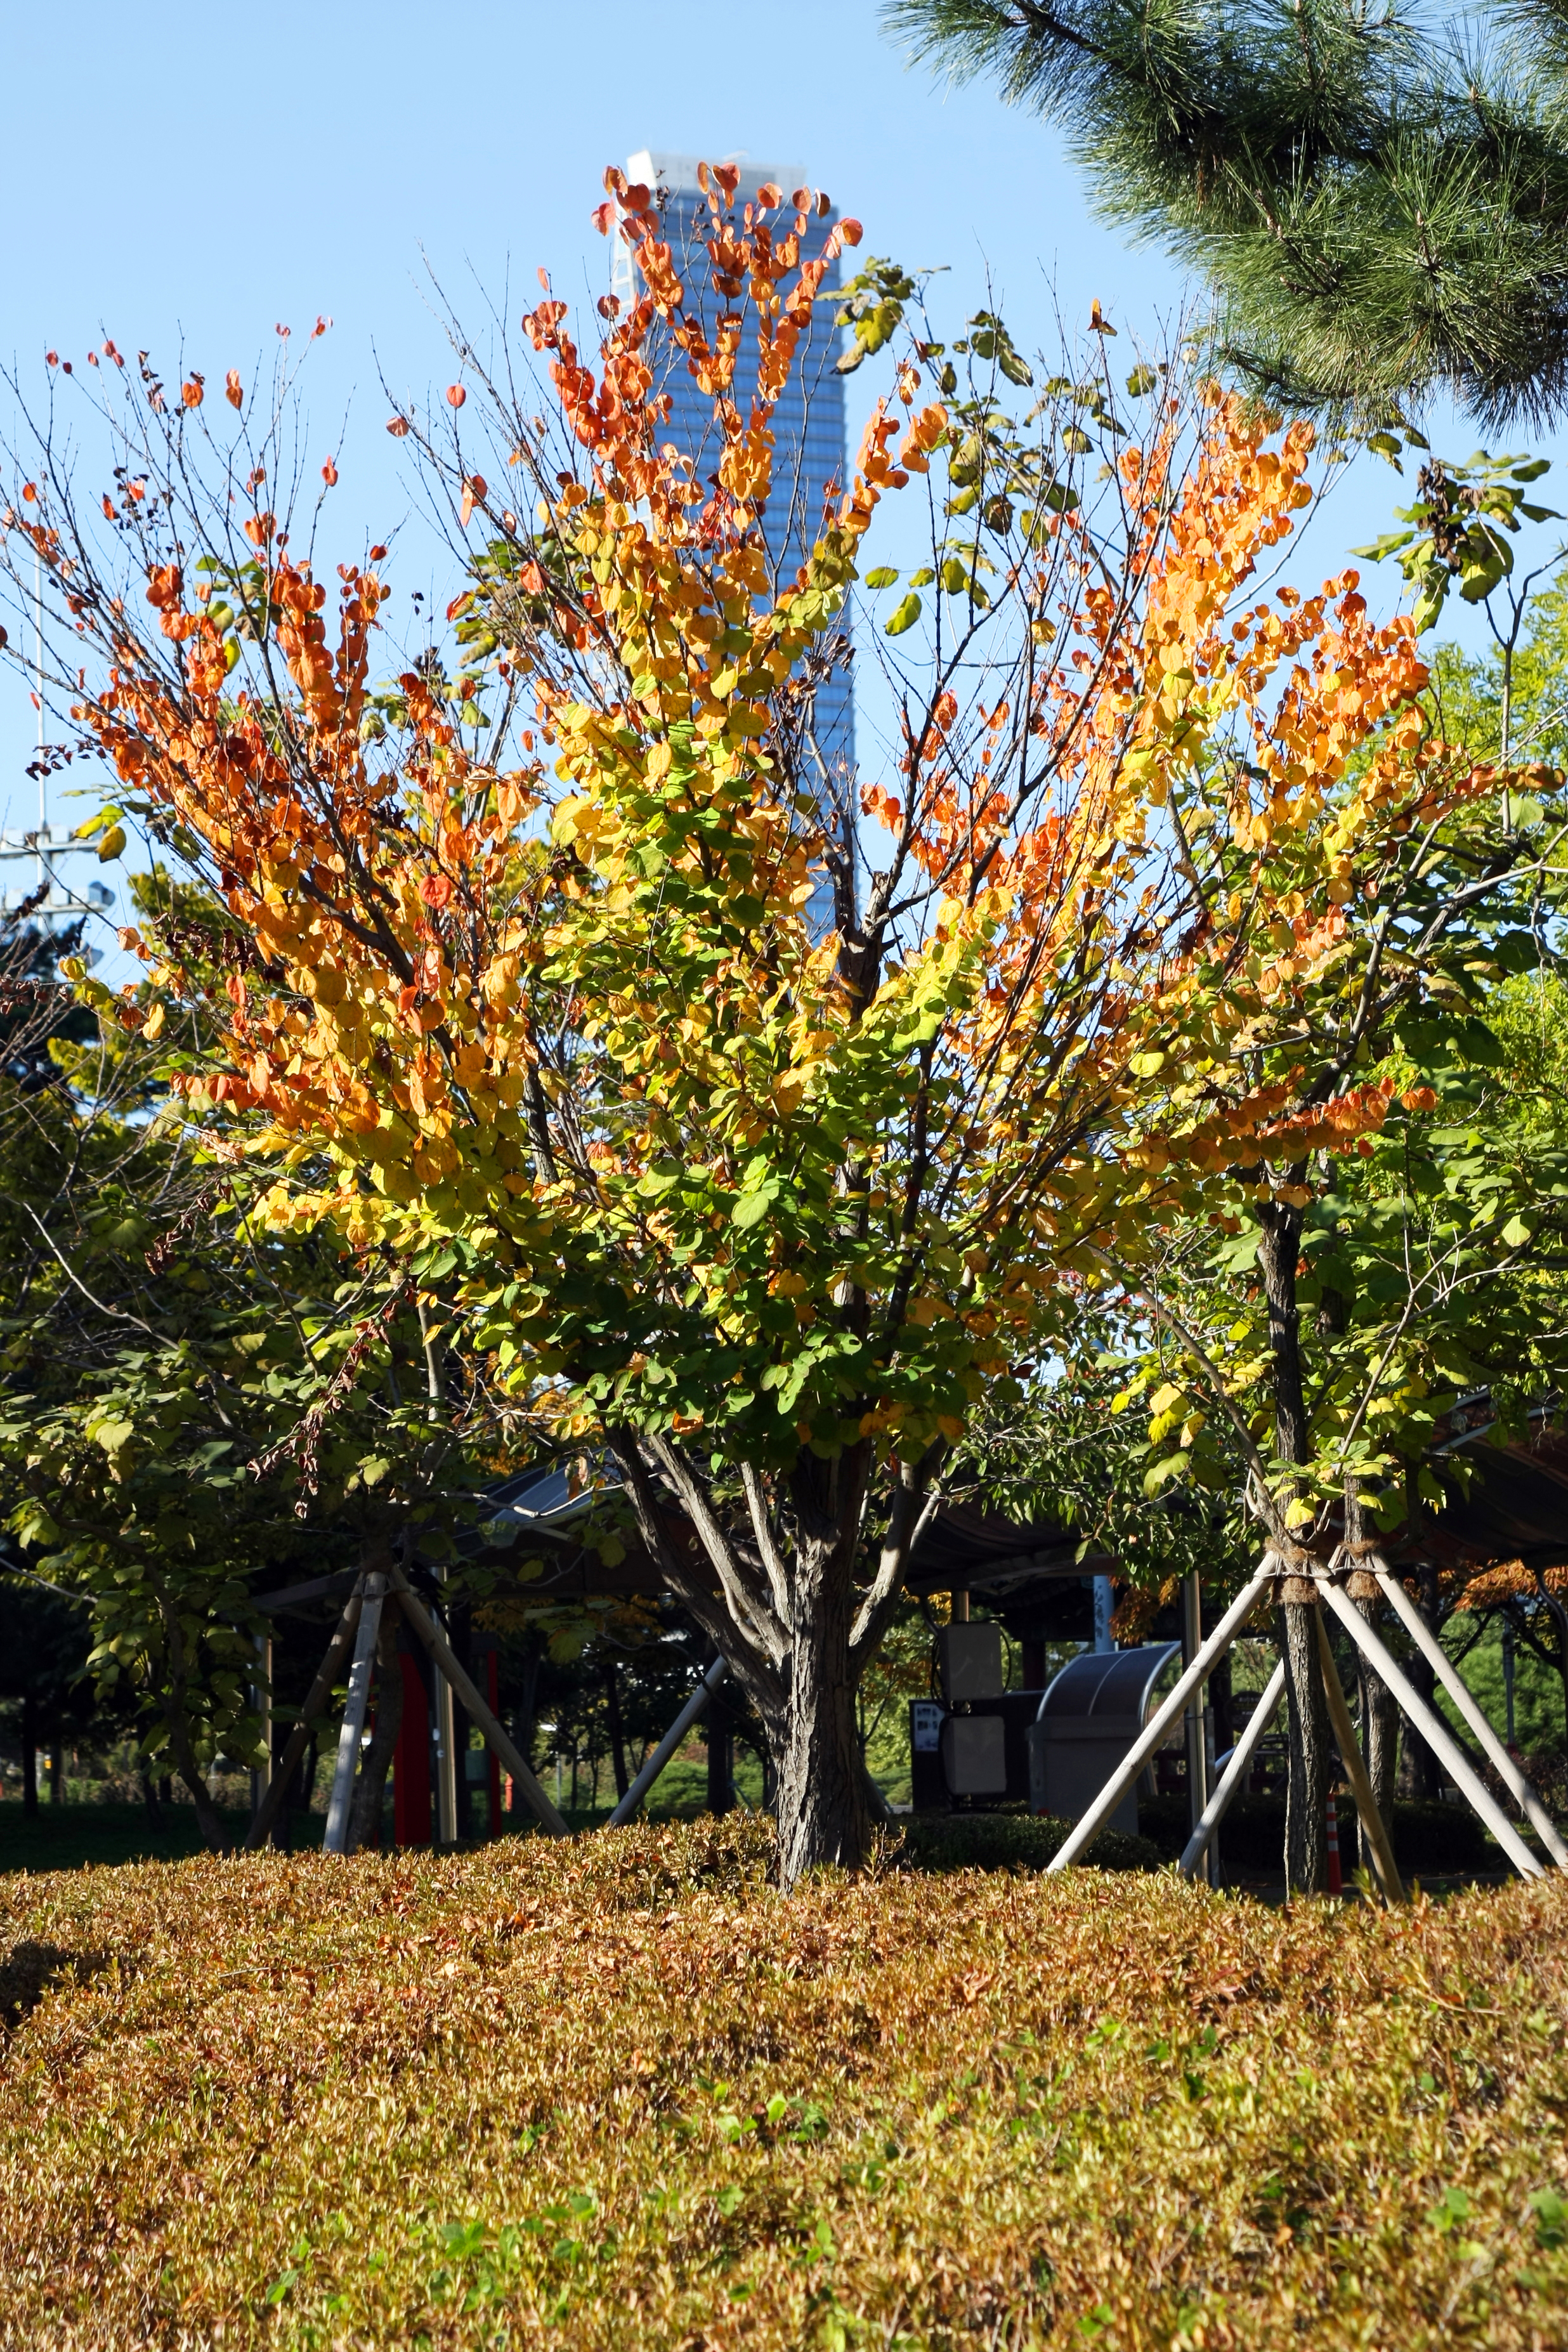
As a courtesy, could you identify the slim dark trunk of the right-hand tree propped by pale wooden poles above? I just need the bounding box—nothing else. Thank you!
[1258,1194,1328,1893]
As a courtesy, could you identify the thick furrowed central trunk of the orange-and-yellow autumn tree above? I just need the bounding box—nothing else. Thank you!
[778,1538,870,1889]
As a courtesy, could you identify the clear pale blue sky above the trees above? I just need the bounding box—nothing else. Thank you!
[0,0,1568,950]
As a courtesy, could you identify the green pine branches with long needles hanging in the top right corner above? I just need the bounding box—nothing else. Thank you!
[886,0,1568,426]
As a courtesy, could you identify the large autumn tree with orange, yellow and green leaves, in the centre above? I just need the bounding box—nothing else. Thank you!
[7,169,1476,1881]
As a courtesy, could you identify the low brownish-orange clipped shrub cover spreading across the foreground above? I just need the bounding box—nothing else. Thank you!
[0,1820,1568,2352]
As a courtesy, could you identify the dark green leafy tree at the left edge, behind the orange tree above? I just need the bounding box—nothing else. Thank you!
[0,875,496,1844]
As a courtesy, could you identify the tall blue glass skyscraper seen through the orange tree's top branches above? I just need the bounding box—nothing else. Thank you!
[613,148,856,769]
